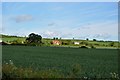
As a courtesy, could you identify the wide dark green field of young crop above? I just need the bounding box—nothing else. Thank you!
[2,46,118,78]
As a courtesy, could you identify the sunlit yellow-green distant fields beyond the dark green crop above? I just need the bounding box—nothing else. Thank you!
[2,37,120,49]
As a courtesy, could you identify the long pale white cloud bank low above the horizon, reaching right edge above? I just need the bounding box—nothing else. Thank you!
[34,21,118,40]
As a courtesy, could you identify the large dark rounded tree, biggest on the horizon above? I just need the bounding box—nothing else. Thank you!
[26,33,42,44]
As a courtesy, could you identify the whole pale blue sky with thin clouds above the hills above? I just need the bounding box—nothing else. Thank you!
[0,2,118,41]
